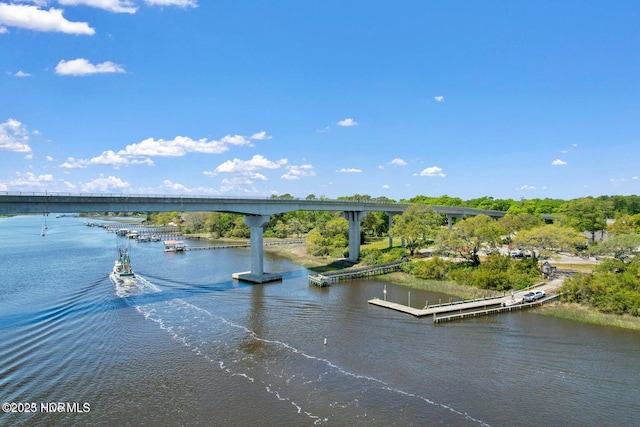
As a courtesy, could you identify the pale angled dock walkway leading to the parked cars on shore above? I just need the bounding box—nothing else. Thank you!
[368,278,564,323]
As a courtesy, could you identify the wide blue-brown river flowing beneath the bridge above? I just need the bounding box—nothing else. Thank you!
[0,215,640,426]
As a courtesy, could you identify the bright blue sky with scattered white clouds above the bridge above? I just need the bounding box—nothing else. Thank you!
[0,0,640,200]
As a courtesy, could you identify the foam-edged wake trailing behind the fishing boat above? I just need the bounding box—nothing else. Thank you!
[116,275,488,426]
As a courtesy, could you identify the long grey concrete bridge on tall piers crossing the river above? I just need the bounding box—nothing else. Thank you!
[0,192,505,283]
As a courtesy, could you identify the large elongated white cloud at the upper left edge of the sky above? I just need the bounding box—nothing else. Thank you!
[0,3,96,35]
